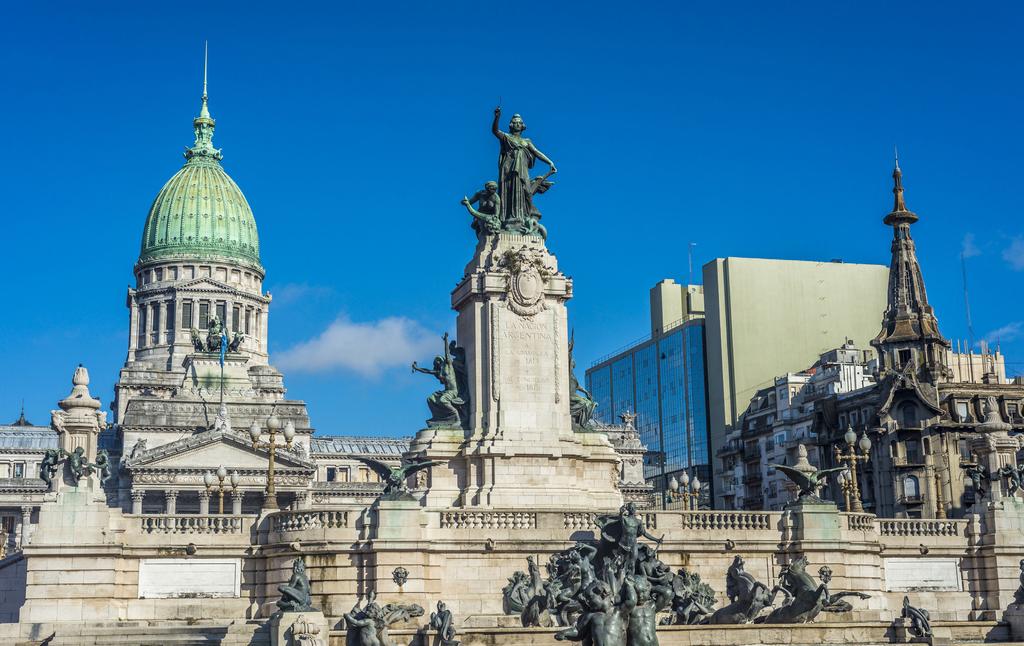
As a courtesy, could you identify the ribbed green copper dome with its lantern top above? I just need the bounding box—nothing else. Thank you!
[138,92,262,271]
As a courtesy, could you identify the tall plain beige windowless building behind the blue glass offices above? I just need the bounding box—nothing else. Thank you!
[703,258,889,502]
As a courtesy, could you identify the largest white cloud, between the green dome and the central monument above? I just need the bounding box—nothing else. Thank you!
[273,315,440,377]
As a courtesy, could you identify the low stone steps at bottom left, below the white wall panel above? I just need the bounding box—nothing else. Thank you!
[18,621,270,646]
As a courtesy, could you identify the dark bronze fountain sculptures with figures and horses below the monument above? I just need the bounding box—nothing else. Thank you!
[503,505,868,646]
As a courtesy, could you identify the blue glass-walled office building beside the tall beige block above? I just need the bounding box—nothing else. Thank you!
[586,315,712,490]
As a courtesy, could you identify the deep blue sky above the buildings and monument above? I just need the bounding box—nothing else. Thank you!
[0,2,1024,435]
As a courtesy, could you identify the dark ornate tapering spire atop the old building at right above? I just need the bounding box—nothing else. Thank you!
[871,158,950,384]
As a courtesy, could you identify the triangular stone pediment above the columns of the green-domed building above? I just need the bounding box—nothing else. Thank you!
[127,431,315,471]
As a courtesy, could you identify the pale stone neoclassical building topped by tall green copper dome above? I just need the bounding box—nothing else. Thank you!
[104,89,407,514]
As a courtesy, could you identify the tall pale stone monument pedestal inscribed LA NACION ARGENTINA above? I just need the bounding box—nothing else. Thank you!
[410,231,623,510]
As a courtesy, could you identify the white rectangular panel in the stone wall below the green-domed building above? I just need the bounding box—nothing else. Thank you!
[138,559,242,599]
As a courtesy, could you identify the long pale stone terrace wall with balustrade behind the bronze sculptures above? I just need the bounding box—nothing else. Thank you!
[12,502,1024,630]
